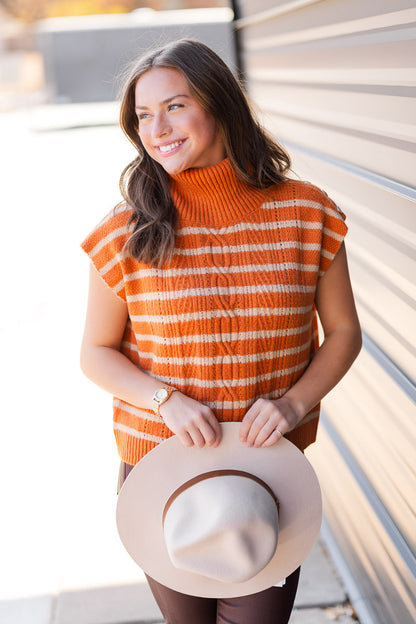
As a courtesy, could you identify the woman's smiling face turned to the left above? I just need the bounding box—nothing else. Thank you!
[135,67,225,175]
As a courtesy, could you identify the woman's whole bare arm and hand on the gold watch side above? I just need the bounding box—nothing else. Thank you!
[81,266,221,446]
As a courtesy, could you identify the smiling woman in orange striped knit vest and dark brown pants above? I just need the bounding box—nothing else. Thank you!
[81,40,361,624]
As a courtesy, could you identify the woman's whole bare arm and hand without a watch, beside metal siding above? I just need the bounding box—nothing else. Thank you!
[240,244,361,446]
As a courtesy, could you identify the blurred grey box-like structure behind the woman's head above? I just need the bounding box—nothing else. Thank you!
[36,7,235,103]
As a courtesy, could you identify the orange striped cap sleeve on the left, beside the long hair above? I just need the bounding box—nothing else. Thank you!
[81,204,132,301]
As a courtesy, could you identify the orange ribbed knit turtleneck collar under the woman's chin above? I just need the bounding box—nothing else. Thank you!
[171,158,267,226]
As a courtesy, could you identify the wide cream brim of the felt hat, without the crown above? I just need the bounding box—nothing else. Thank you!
[116,423,322,598]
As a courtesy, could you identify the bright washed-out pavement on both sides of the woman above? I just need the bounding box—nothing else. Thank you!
[0,103,356,624]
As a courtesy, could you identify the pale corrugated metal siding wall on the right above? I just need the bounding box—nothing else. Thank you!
[236,0,416,624]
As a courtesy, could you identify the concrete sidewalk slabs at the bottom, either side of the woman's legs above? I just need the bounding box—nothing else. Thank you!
[0,540,357,624]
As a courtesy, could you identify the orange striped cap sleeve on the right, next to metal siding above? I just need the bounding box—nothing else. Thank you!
[319,191,348,277]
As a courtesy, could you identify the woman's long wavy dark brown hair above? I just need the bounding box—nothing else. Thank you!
[120,39,290,267]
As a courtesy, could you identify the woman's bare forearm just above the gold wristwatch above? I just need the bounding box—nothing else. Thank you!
[81,346,162,409]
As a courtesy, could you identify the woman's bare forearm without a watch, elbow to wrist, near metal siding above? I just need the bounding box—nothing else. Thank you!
[284,326,361,422]
